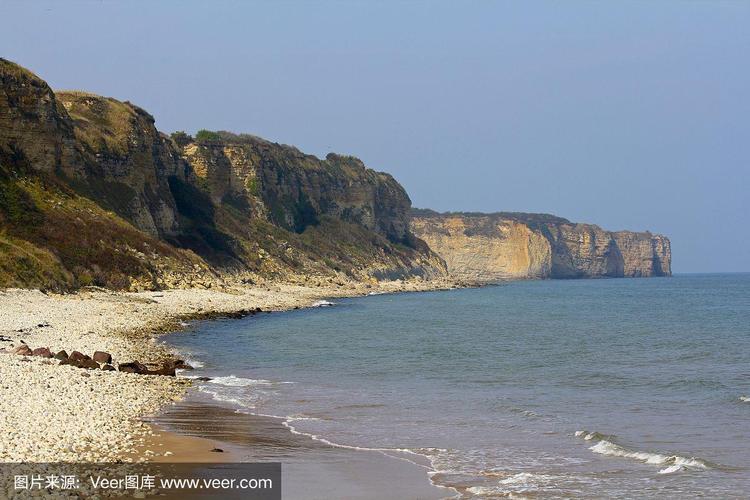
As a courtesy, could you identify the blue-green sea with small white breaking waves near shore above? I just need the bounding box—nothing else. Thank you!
[170,274,750,498]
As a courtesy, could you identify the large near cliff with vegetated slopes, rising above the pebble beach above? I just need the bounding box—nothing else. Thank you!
[0,59,446,290]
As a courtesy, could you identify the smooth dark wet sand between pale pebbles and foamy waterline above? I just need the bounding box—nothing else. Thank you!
[155,395,446,499]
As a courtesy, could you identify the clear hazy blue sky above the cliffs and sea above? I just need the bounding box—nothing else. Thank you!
[0,0,750,273]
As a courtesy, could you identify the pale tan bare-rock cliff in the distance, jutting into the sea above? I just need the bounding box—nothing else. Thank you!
[411,210,671,282]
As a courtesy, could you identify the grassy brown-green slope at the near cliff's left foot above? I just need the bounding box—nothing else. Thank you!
[0,154,201,290]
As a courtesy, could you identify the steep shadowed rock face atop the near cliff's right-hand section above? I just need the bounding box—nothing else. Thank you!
[182,136,418,244]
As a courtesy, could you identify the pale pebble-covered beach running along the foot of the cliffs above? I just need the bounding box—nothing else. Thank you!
[0,281,458,462]
